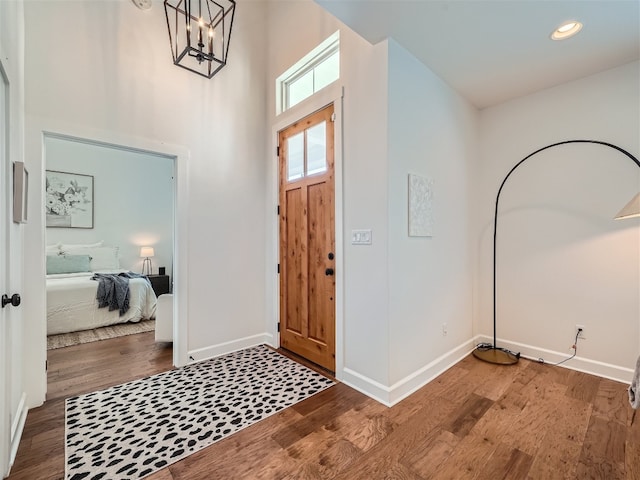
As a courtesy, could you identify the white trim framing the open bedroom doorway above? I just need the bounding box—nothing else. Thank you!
[27,122,190,407]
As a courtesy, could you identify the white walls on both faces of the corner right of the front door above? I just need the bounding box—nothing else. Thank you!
[267,1,477,403]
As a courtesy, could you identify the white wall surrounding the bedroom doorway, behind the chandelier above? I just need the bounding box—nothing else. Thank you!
[26,0,266,401]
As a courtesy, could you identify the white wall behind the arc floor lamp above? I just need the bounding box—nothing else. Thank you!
[475,62,640,381]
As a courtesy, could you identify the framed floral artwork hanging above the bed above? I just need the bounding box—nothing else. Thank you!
[45,170,93,228]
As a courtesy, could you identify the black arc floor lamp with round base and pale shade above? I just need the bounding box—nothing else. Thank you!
[473,140,640,365]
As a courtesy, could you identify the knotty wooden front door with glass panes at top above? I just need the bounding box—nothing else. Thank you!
[278,105,335,371]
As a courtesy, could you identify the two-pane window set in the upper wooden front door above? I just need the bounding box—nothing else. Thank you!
[286,121,327,182]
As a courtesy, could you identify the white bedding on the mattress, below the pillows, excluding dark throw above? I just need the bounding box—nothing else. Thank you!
[47,272,157,335]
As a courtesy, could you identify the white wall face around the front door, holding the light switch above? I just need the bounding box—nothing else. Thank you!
[267,0,389,388]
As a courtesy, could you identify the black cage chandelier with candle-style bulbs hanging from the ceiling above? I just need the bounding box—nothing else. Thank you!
[164,0,236,78]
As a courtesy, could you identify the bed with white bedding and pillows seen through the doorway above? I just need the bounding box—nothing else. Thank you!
[47,244,157,335]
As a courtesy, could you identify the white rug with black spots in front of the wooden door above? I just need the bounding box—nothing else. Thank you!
[65,345,334,480]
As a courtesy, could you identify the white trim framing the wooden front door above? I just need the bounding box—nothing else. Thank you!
[267,83,345,380]
